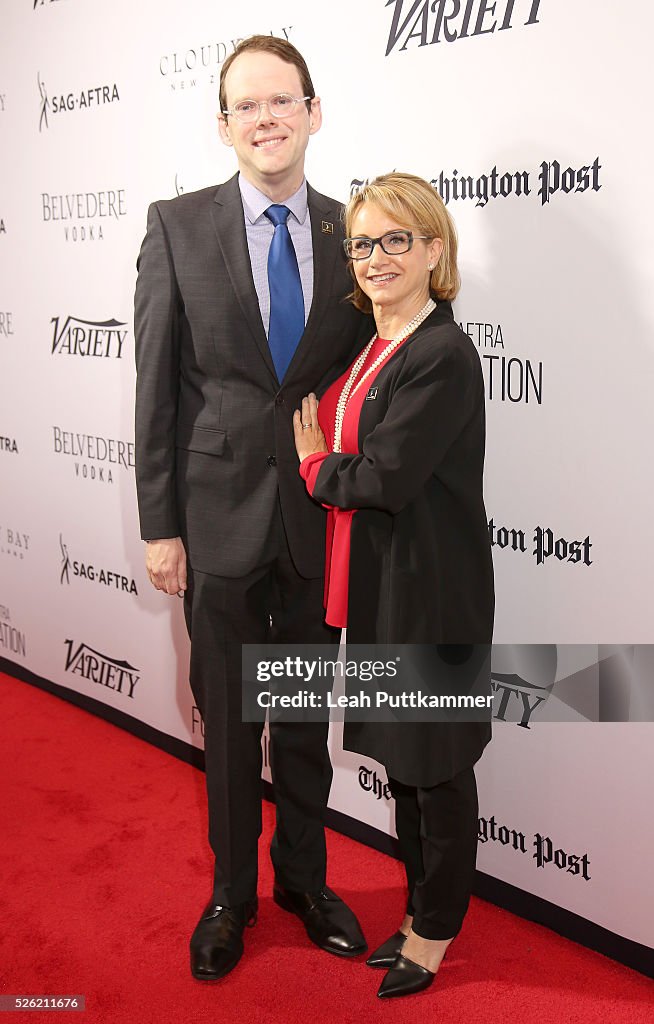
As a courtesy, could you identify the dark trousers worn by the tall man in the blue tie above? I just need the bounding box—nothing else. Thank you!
[184,515,339,906]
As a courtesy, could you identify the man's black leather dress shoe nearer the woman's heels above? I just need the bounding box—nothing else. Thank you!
[272,882,367,956]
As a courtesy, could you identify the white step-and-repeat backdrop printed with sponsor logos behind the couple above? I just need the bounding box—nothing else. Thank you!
[0,0,654,966]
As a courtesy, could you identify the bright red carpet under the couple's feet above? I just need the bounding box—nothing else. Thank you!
[0,676,654,1024]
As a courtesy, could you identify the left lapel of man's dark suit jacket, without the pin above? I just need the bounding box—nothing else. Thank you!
[211,174,277,381]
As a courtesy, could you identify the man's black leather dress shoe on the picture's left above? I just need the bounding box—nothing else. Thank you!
[190,899,257,981]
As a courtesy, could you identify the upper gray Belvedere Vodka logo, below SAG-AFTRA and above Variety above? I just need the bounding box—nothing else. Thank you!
[41,188,127,242]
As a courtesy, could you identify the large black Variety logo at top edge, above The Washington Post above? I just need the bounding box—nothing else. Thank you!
[385,0,540,56]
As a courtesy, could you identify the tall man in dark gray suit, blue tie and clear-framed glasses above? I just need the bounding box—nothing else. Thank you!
[135,36,370,980]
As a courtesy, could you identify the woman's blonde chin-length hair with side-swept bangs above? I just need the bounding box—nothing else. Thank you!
[345,171,461,313]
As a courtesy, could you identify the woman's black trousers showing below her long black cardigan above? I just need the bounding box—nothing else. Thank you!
[389,767,479,939]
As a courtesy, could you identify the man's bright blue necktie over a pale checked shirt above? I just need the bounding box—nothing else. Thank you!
[266,204,304,383]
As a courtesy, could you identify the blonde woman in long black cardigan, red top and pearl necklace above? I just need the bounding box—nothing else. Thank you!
[294,173,493,996]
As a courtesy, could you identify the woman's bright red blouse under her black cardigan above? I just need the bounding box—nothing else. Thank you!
[300,338,404,628]
